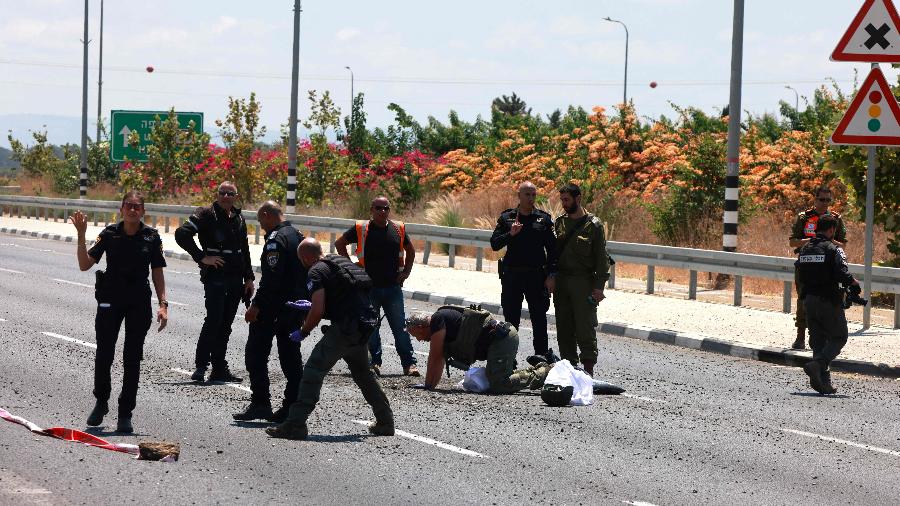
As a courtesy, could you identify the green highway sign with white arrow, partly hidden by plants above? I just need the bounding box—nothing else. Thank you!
[109,110,203,162]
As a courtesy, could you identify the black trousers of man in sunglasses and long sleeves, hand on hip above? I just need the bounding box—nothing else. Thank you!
[194,273,244,370]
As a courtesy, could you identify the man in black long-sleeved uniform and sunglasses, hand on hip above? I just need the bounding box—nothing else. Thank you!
[175,181,254,382]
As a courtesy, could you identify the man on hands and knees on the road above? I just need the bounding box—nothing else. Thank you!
[406,306,552,394]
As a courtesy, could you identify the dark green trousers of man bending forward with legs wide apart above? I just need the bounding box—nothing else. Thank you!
[286,321,393,424]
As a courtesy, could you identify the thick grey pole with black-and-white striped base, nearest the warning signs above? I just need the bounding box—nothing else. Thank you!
[722,0,744,251]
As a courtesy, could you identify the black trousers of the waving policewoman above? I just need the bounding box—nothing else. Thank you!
[94,293,153,414]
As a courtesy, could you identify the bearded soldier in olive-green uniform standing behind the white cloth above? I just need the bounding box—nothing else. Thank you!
[547,184,609,376]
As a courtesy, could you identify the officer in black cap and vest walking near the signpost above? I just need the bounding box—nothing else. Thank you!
[796,214,859,394]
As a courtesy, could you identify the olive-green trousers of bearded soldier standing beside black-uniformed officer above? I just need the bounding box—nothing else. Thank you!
[553,274,597,365]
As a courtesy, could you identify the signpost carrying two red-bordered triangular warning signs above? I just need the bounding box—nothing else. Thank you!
[829,0,900,329]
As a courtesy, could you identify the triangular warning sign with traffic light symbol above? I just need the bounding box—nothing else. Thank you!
[829,67,900,146]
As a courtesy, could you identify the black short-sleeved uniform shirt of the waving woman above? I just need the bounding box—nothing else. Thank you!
[88,222,166,286]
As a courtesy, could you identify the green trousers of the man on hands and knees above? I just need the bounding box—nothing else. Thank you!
[486,327,552,394]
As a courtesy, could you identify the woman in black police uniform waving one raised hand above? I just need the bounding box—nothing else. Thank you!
[69,191,169,433]
